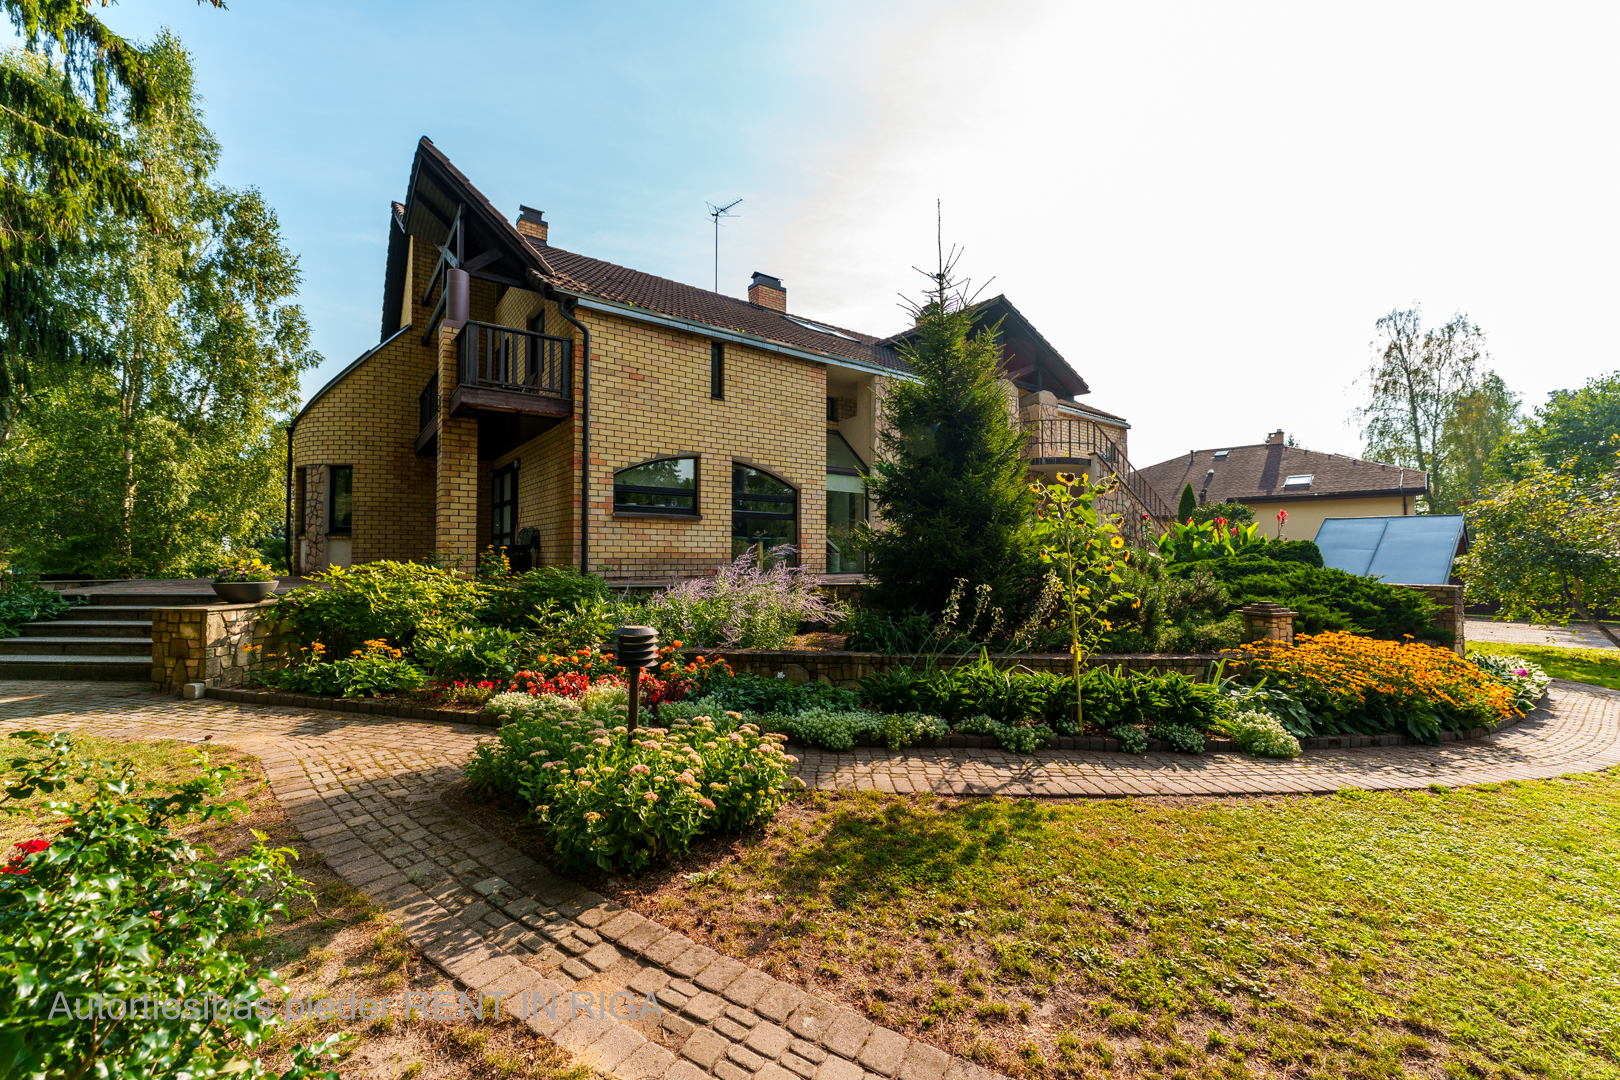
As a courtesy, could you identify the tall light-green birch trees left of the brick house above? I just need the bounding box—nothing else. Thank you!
[0,33,321,576]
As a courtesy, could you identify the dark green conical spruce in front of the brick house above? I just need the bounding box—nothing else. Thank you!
[863,248,1043,619]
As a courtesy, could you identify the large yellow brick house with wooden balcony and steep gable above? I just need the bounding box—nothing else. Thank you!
[288,139,1168,580]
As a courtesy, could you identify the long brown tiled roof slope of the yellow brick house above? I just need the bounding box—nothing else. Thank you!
[528,238,906,371]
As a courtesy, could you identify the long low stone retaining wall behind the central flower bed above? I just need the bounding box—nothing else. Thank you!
[684,649,1236,687]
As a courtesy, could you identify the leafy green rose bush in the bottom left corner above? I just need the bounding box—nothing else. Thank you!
[0,732,339,1080]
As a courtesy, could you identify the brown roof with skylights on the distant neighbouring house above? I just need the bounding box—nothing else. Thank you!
[1137,442,1429,505]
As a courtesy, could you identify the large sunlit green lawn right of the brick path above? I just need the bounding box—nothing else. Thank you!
[622,772,1620,1077]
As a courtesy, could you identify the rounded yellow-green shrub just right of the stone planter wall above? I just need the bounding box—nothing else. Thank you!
[274,560,483,654]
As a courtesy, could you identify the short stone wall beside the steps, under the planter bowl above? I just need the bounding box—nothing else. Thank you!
[152,601,282,693]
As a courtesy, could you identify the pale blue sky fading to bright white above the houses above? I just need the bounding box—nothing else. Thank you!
[94,0,1620,466]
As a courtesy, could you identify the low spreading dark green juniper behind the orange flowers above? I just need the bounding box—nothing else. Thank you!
[1170,555,1445,640]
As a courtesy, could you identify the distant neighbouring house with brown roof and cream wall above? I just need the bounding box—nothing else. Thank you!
[1140,431,1429,539]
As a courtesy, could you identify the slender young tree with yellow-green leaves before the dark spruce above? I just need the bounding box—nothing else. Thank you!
[1029,473,1137,730]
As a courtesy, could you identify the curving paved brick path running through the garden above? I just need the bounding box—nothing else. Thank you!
[0,682,1620,1080]
